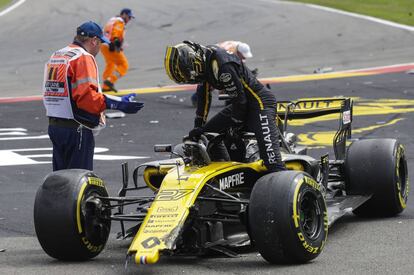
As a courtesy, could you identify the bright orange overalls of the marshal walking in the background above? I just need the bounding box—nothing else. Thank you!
[101,17,129,90]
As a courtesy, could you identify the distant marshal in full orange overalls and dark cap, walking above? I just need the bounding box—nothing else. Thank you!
[101,9,135,92]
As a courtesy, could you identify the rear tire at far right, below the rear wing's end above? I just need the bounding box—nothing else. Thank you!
[345,139,409,217]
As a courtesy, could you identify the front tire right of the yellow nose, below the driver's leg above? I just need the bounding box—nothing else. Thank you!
[248,171,328,264]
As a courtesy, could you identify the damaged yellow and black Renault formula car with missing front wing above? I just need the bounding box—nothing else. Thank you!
[34,98,409,264]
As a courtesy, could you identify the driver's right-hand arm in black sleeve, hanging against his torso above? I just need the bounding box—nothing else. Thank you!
[219,63,247,123]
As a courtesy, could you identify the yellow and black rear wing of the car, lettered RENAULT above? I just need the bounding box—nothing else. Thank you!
[276,98,353,160]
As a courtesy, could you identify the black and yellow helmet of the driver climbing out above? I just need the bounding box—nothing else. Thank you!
[164,41,205,84]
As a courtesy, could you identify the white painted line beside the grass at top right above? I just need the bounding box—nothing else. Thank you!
[259,0,414,32]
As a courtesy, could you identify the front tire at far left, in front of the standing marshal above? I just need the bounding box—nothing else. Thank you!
[34,169,111,260]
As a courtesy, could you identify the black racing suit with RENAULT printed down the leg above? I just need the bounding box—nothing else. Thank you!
[194,45,285,172]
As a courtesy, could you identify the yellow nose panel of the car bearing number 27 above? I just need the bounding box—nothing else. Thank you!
[128,160,266,264]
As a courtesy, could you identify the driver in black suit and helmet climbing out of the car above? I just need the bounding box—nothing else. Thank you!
[164,41,285,172]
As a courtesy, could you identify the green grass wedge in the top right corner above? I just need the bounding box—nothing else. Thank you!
[291,0,414,26]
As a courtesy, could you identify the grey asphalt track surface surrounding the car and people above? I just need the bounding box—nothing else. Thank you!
[0,0,414,274]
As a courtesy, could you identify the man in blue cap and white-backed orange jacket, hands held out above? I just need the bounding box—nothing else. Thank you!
[43,21,144,171]
